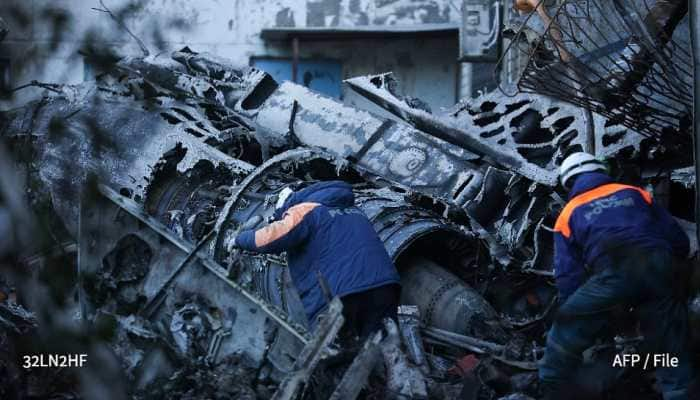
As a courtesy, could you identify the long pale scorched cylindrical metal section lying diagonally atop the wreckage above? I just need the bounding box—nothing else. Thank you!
[239,82,486,209]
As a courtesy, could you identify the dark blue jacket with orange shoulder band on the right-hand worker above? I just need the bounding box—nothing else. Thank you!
[554,172,689,300]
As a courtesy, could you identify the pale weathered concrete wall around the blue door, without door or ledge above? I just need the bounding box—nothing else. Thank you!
[0,0,460,109]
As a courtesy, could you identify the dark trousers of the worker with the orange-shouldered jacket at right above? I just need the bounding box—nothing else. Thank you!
[539,249,692,400]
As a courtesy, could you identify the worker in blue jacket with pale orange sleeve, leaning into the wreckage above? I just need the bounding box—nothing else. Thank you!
[231,181,400,338]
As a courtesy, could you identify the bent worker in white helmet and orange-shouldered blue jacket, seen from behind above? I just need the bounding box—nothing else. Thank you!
[539,153,691,400]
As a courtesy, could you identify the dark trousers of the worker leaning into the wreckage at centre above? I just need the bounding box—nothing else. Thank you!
[341,284,401,340]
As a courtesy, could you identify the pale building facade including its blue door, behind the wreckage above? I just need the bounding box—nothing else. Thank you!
[0,0,498,112]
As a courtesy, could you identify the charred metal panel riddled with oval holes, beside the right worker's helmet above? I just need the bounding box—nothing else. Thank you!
[348,75,588,271]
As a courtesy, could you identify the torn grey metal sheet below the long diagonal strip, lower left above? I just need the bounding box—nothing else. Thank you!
[80,189,269,387]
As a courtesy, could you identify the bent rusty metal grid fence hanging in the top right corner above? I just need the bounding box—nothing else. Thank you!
[506,0,693,145]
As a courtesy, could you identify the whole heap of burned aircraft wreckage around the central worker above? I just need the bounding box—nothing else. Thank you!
[0,44,694,399]
